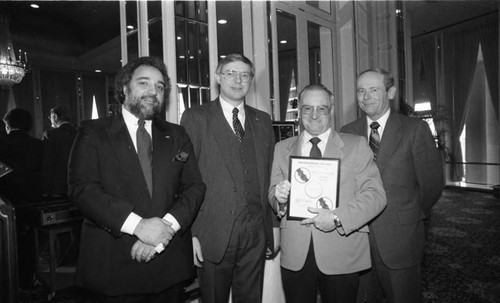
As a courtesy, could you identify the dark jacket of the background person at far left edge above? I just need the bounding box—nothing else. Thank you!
[0,130,42,205]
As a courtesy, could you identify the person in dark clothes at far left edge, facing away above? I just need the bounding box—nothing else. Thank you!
[0,108,42,289]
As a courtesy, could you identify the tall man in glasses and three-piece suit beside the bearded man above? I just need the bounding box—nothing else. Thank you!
[181,54,274,303]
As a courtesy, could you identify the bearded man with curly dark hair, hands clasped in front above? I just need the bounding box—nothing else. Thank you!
[69,57,205,302]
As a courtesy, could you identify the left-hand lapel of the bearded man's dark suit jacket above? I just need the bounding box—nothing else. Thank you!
[107,115,149,197]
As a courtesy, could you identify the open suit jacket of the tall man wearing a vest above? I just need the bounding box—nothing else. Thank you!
[181,99,274,263]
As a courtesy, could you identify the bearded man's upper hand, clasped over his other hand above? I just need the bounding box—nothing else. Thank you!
[134,218,175,247]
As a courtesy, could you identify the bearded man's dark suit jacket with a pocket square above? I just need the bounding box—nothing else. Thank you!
[69,115,205,295]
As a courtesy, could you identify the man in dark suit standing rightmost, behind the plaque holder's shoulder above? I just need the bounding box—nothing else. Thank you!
[341,69,444,303]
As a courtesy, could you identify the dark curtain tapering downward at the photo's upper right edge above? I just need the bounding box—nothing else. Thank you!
[479,24,499,118]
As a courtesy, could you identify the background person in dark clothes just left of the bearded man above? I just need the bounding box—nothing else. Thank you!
[42,106,76,197]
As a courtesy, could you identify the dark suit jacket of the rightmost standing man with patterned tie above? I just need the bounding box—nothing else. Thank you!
[341,111,444,269]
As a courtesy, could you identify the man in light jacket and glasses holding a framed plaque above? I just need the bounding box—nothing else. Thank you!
[269,84,386,303]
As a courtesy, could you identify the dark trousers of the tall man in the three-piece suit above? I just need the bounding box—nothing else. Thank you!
[198,209,266,303]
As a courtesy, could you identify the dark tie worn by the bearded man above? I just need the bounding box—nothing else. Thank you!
[137,119,153,196]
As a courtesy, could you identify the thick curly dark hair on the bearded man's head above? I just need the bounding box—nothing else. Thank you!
[115,57,170,104]
